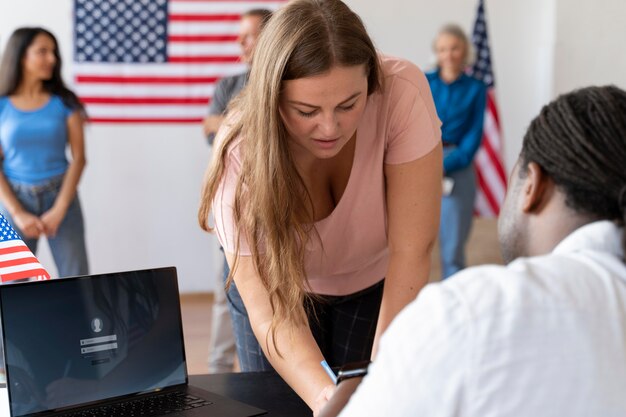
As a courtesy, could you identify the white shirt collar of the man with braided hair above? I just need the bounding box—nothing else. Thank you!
[553,220,624,259]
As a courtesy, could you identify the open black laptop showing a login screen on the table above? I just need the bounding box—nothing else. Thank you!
[0,267,265,417]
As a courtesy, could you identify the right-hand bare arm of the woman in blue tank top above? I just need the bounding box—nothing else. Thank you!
[41,111,87,237]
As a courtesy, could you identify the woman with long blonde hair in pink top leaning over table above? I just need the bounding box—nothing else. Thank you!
[199,0,442,411]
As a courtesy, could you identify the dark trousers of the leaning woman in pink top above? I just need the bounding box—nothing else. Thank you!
[227,280,384,372]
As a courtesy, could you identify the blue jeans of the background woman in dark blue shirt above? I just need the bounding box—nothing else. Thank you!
[439,148,476,279]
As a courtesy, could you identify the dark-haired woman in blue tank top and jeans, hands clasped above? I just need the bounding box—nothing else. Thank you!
[0,28,88,277]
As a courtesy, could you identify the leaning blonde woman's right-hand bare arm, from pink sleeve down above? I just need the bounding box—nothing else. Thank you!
[372,144,442,357]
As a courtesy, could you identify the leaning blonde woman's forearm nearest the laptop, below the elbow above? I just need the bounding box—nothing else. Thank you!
[253,316,333,408]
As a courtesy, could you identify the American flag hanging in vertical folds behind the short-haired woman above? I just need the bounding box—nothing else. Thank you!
[468,0,506,217]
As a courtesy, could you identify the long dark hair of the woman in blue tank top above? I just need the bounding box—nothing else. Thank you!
[0,27,86,116]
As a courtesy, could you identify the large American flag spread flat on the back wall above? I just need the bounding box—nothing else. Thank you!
[73,0,285,123]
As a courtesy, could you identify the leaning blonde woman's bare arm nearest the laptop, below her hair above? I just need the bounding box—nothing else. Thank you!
[226,250,333,411]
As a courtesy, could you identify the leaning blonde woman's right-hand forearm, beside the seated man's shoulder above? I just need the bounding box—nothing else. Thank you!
[372,249,430,358]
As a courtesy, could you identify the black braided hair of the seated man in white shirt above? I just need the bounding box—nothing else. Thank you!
[520,86,626,253]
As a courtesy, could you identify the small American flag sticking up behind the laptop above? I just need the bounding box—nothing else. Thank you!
[0,214,50,283]
